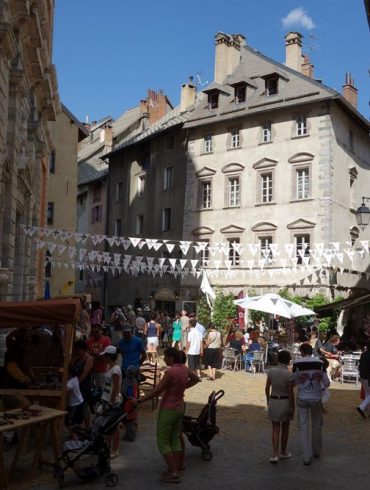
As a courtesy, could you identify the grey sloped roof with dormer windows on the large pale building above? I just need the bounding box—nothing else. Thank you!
[184,41,364,127]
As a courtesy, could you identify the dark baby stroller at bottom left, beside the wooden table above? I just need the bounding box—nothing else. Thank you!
[54,405,127,488]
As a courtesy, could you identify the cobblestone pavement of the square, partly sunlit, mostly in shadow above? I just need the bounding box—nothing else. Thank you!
[34,371,370,490]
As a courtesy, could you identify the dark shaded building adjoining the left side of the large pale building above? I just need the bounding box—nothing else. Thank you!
[101,83,197,313]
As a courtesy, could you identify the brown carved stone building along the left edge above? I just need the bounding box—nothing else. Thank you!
[0,0,60,301]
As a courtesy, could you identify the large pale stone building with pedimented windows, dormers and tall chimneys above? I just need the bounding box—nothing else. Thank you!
[182,33,370,299]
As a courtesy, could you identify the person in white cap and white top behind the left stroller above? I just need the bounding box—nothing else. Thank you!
[100,345,122,459]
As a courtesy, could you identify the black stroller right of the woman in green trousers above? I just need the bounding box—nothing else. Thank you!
[182,390,225,461]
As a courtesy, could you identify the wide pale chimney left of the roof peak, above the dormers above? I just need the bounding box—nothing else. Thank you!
[214,32,245,84]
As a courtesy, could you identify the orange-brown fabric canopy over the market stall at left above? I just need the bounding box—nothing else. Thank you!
[0,299,81,328]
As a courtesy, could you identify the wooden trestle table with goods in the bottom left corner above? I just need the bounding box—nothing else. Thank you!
[0,405,66,489]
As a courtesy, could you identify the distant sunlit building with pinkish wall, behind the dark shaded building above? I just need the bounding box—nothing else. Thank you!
[76,90,172,304]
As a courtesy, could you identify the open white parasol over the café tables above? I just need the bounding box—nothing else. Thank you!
[234,293,315,318]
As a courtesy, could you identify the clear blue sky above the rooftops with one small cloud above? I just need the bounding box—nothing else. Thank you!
[54,0,370,121]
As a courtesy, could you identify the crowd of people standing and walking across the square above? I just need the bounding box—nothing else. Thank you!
[1,305,370,483]
